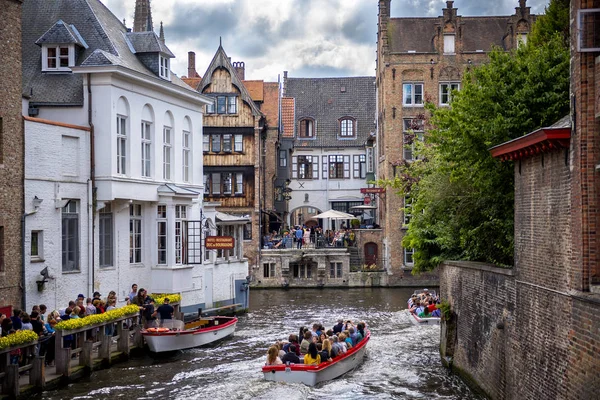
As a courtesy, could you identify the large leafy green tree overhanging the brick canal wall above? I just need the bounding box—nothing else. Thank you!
[387,34,569,272]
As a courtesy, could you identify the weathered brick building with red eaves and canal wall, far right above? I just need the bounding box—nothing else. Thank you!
[440,0,600,399]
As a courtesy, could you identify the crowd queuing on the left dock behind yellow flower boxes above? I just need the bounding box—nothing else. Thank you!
[0,284,174,365]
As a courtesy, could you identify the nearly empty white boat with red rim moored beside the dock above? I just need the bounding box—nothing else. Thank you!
[142,317,237,353]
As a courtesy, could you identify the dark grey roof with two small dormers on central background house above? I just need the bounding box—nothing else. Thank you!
[283,76,375,148]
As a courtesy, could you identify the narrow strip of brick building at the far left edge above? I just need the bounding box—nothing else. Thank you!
[0,0,24,311]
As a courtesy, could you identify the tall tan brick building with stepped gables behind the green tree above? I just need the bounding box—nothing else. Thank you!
[376,0,535,279]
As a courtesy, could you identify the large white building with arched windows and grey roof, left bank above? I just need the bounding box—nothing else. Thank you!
[23,0,247,311]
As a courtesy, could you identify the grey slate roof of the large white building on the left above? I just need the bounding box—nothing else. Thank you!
[22,0,191,106]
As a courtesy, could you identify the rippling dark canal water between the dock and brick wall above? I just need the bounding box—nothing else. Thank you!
[38,288,479,400]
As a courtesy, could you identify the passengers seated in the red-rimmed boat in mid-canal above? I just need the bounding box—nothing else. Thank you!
[265,319,366,365]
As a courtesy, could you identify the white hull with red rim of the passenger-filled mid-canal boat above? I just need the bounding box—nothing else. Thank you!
[263,331,371,386]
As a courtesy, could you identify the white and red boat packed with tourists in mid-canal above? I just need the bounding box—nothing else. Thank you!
[262,319,371,386]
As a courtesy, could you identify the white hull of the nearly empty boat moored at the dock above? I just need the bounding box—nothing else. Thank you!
[142,318,237,353]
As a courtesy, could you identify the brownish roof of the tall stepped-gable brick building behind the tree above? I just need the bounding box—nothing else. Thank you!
[388,16,511,53]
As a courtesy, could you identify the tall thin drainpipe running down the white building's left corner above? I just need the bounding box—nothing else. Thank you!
[87,73,96,294]
